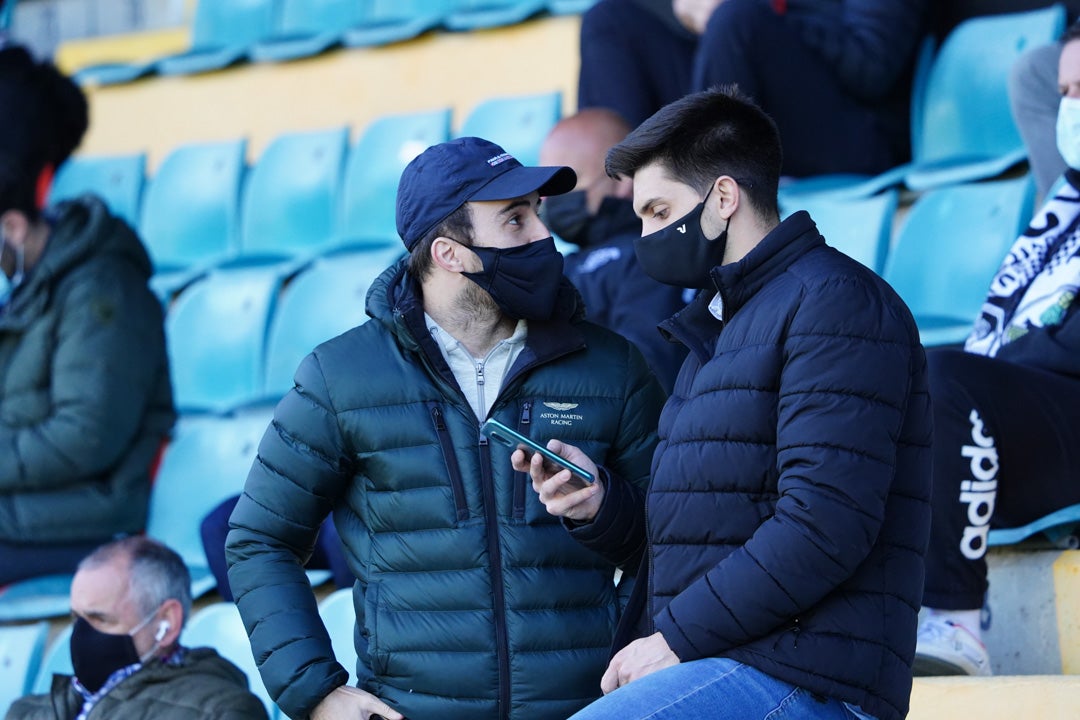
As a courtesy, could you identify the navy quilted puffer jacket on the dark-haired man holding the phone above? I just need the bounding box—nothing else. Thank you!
[575,213,932,720]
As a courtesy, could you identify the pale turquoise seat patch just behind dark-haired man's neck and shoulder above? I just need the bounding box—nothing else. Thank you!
[781,188,900,274]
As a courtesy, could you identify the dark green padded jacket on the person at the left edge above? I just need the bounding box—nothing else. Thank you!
[0,196,174,543]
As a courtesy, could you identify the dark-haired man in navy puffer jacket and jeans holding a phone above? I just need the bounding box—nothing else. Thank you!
[512,91,931,720]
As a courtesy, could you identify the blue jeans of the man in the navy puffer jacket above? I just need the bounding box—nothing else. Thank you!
[570,657,873,720]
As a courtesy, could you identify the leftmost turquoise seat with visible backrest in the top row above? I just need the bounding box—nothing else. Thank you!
[153,0,279,74]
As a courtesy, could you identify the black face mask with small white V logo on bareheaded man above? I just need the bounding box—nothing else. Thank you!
[634,190,731,290]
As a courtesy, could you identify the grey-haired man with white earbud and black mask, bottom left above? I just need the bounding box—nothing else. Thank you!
[6,535,267,720]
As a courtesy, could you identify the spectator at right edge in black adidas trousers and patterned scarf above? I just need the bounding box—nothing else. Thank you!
[915,19,1080,675]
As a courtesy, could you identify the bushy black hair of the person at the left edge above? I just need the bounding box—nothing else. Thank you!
[0,45,90,219]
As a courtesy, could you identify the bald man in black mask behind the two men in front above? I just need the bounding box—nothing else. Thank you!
[540,108,686,393]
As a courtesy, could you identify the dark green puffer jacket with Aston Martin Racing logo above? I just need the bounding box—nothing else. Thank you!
[227,263,663,720]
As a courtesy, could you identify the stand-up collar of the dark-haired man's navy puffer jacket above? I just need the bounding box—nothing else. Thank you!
[660,210,825,363]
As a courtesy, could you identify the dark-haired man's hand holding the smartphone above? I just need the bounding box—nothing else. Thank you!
[510,440,604,522]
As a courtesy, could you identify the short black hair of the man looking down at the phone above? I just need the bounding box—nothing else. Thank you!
[605,85,783,217]
